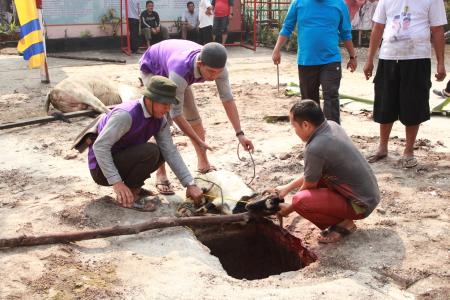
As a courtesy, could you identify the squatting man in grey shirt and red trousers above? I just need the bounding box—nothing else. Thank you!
[275,100,380,243]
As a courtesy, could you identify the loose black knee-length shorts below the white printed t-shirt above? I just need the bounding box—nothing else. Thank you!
[373,59,431,126]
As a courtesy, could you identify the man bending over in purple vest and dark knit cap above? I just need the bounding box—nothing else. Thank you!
[140,40,253,194]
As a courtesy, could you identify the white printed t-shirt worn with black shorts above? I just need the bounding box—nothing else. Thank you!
[372,0,447,60]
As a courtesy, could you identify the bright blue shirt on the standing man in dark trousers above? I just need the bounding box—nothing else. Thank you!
[280,0,352,66]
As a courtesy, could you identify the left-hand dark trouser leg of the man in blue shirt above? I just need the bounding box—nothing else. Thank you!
[298,65,320,106]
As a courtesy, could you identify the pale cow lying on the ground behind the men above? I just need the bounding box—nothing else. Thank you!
[44,76,140,113]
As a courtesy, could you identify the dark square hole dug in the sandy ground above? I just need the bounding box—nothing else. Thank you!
[194,219,317,280]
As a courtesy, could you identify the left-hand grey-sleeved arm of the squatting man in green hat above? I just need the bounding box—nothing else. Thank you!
[93,111,134,207]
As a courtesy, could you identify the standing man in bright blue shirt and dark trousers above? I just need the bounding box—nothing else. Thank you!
[272,0,357,123]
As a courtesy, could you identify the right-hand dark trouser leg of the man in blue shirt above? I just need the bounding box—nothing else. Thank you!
[320,62,342,124]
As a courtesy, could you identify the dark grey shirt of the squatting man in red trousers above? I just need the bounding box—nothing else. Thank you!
[304,121,380,216]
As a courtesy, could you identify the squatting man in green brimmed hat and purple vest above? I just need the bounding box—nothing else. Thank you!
[88,76,202,211]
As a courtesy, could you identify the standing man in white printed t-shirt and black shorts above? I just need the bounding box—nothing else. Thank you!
[364,0,447,168]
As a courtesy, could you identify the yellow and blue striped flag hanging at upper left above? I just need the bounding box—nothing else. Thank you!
[15,0,46,81]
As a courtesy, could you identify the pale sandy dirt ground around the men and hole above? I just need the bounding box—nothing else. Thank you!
[0,48,450,299]
